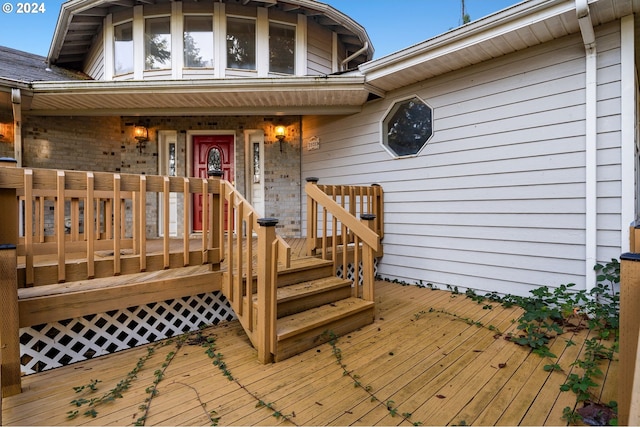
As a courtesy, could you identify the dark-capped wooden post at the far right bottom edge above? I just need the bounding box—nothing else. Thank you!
[618,253,640,425]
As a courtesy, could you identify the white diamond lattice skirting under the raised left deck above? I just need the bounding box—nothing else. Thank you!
[20,292,236,375]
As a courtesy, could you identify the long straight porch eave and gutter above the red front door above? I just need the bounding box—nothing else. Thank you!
[25,76,371,115]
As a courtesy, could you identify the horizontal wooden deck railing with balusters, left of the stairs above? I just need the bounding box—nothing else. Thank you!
[0,168,220,287]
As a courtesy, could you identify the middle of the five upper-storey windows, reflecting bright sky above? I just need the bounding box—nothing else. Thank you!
[184,16,213,68]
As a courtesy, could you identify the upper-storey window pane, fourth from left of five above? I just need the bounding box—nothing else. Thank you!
[227,18,256,70]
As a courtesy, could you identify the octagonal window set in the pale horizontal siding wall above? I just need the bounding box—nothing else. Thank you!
[382,96,433,157]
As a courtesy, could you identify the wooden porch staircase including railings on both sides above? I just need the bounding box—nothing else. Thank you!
[219,180,382,363]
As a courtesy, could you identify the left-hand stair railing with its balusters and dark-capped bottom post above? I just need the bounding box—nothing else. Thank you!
[221,181,291,363]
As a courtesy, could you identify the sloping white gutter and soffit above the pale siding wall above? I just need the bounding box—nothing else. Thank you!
[359,0,638,92]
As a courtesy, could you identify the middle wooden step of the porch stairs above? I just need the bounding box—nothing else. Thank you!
[277,276,351,318]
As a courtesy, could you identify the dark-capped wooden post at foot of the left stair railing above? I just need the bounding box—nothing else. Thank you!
[257,218,278,363]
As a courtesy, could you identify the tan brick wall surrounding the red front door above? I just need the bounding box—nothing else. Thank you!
[17,116,301,237]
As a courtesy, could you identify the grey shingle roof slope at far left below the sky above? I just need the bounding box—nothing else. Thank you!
[0,46,91,83]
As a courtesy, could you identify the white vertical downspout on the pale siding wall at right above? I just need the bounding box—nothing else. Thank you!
[576,0,598,292]
